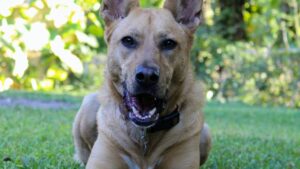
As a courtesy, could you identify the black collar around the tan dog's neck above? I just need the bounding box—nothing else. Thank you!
[147,108,180,133]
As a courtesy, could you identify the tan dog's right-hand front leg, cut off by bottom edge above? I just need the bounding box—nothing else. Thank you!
[157,133,200,169]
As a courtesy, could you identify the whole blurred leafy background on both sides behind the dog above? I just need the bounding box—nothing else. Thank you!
[0,0,300,107]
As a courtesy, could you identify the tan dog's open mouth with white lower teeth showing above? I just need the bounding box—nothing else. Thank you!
[124,92,163,128]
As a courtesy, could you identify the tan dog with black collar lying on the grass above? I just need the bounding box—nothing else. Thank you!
[73,0,210,169]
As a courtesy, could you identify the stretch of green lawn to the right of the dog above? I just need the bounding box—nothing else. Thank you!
[204,103,300,169]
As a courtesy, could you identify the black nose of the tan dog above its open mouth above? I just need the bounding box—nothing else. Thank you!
[135,66,159,86]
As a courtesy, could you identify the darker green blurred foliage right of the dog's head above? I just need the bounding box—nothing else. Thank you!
[192,0,300,107]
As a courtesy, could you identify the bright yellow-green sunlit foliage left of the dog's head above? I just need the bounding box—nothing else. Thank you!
[0,0,105,90]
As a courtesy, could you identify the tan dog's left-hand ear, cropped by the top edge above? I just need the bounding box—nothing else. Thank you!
[101,0,139,26]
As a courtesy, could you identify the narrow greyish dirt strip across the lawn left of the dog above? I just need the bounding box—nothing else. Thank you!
[0,98,78,109]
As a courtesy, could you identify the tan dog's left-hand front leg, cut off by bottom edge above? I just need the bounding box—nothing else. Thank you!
[86,135,127,169]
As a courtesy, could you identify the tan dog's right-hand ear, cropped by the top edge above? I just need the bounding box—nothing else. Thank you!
[164,0,203,32]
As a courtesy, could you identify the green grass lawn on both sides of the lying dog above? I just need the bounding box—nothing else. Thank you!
[0,92,300,169]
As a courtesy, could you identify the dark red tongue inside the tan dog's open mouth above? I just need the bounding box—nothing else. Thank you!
[133,94,155,113]
